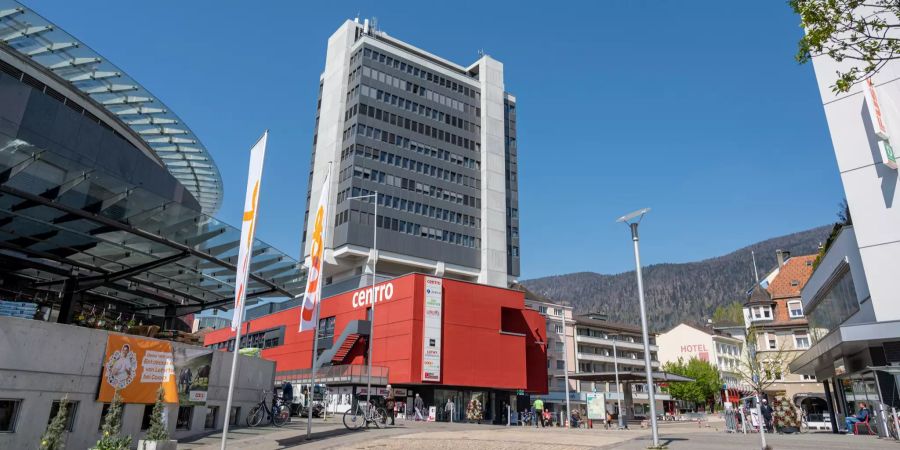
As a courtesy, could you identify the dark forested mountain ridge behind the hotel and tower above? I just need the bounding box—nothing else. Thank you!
[522,226,831,331]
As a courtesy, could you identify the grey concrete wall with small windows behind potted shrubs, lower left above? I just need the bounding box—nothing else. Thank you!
[0,317,275,449]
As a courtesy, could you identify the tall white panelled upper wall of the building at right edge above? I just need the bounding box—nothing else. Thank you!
[813,22,900,322]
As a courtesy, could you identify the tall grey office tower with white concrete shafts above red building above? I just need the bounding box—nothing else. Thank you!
[303,20,519,292]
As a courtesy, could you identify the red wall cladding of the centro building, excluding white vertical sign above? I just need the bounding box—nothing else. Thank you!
[204,274,547,392]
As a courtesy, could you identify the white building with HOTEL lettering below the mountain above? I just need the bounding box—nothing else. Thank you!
[656,323,745,388]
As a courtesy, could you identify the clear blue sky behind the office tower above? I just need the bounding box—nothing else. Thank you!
[26,0,843,279]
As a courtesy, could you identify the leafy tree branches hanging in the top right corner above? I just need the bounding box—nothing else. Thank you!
[789,0,900,93]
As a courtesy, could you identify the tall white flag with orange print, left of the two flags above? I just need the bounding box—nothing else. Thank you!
[231,131,269,330]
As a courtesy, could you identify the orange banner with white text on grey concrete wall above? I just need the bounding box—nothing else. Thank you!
[97,334,178,403]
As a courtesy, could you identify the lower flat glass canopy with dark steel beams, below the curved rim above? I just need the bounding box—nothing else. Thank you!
[0,134,306,314]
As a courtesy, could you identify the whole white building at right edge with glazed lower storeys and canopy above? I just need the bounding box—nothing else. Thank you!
[790,2,900,432]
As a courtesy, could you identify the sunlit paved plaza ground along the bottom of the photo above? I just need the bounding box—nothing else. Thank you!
[178,418,900,450]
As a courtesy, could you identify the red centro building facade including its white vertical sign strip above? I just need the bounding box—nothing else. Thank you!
[204,274,547,422]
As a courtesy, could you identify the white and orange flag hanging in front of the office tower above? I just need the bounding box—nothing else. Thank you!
[300,171,331,332]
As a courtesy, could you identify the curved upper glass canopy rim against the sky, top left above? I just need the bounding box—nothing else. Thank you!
[0,0,222,214]
